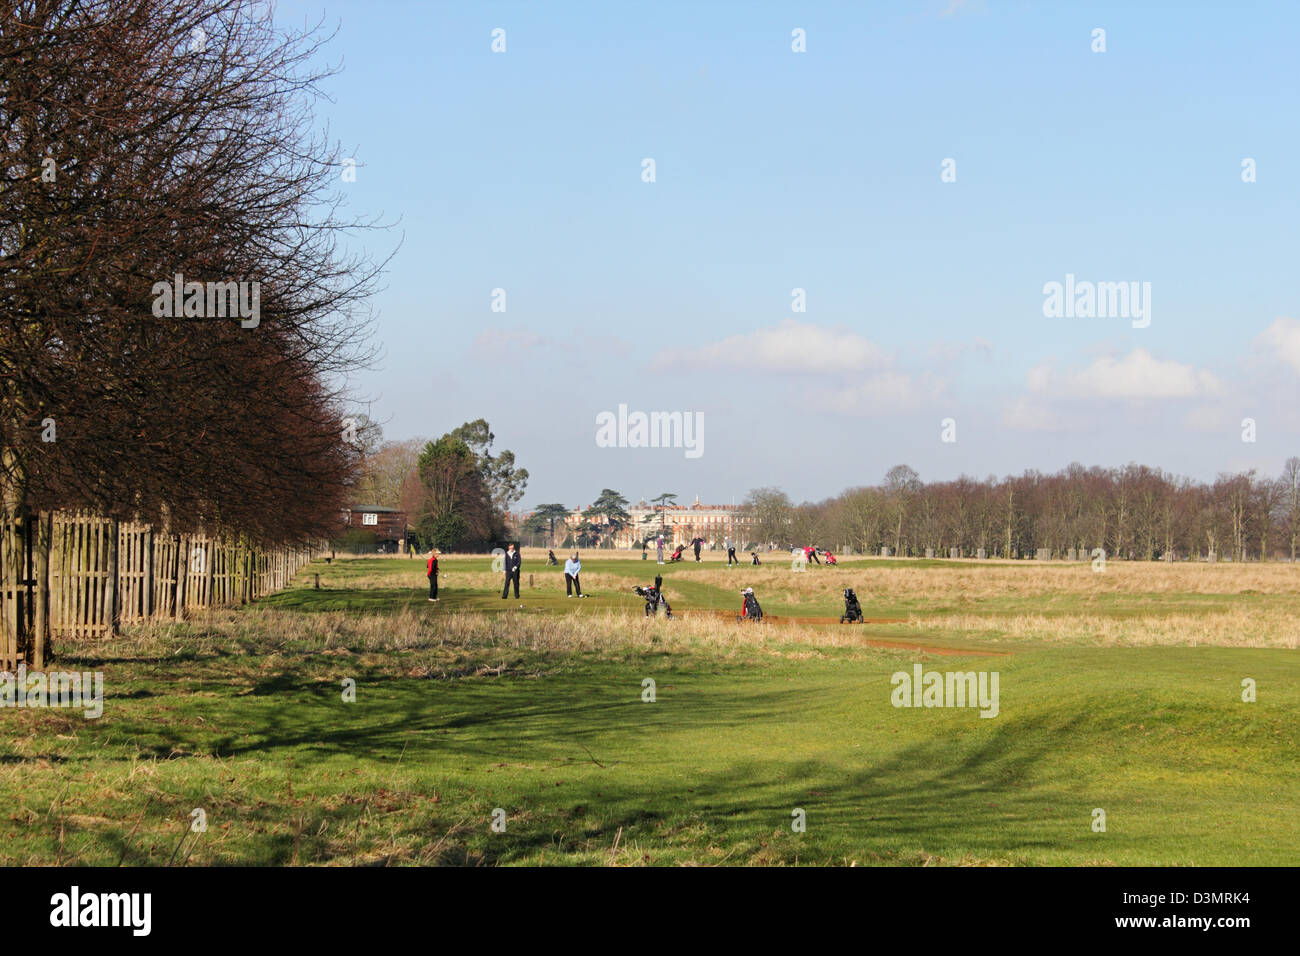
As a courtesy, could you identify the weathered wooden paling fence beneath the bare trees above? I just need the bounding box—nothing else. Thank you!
[0,511,317,670]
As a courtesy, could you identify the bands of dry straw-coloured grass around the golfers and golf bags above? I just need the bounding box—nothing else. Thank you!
[91,553,1300,658]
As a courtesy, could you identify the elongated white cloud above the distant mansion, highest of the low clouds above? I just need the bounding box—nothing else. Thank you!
[655,319,889,373]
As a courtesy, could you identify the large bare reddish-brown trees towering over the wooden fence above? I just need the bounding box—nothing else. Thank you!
[0,0,378,544]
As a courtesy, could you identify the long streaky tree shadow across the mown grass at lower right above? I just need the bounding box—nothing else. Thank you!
[465,708,1149,862]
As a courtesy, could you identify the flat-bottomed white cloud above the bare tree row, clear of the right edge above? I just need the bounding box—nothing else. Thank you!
[1027,349,1223,401]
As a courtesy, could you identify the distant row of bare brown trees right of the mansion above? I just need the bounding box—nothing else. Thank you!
[746,458,1300,561]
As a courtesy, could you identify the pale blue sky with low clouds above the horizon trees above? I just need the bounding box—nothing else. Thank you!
[278,0,1300,506]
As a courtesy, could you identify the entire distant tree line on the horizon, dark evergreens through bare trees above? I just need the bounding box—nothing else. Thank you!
[361,447,1300,561]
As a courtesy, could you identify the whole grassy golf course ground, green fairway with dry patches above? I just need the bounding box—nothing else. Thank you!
[0,557,1300,866]
